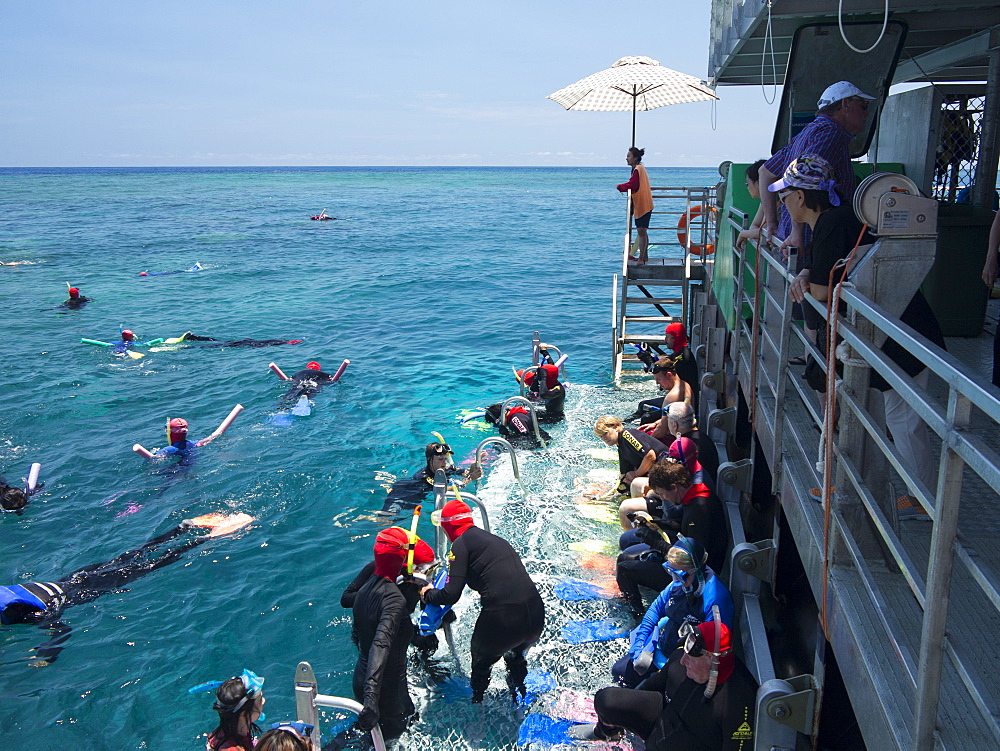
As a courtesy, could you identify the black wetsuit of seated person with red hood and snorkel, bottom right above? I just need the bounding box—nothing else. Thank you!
[594,650,757,751]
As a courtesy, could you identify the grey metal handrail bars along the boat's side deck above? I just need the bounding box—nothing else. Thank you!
[726,234,1000,748]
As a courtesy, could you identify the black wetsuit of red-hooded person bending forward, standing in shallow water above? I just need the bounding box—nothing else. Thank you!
[424,527,545,702]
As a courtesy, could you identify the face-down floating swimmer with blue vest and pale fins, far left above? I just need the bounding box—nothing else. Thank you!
[0,514,254,667]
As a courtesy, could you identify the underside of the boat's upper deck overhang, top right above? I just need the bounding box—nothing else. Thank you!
[708,0,1000,86]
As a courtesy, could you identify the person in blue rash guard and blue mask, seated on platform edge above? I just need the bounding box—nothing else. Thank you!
[611,537,735,688]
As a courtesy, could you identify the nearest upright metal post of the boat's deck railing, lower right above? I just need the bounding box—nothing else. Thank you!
[913,390,972,751]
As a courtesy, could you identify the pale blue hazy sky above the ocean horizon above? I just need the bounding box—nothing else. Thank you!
[0,0,780,167]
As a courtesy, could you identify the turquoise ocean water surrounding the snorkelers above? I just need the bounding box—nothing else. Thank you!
[0,165,718,749]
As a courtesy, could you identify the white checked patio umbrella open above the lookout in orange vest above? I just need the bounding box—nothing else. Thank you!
[546,55,719,146]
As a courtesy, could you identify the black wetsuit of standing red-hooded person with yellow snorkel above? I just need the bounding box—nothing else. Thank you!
[353,576,415,739]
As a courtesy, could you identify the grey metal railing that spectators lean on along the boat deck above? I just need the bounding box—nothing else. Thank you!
[724,203,1000,749]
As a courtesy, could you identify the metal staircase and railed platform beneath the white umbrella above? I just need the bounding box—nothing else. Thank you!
[611,187,716,384]
